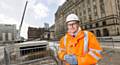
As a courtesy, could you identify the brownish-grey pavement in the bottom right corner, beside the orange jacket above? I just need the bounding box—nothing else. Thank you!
[99,49,120,65]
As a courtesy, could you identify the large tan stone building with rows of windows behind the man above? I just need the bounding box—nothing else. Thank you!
[55,0,120,38]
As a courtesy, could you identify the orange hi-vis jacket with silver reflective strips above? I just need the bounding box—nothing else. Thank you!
[58,31,102,65]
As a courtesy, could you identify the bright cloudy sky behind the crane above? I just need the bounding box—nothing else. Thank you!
[0,0,66,39]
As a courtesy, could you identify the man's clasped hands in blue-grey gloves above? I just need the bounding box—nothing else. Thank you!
[64,54,77,64]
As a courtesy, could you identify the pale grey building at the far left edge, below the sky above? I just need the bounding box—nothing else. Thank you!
[0,24,17,43]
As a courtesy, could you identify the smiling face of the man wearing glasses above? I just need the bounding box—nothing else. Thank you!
[67,21,79,33]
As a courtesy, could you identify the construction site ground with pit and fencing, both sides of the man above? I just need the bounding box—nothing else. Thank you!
[0,41,120,65]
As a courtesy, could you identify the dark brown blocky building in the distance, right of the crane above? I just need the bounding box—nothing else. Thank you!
[28,27,45,40]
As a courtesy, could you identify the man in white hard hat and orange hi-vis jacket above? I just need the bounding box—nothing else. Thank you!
[58,14,102,65]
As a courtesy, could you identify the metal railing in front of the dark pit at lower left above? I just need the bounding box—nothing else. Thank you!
[0,46,57,65]
